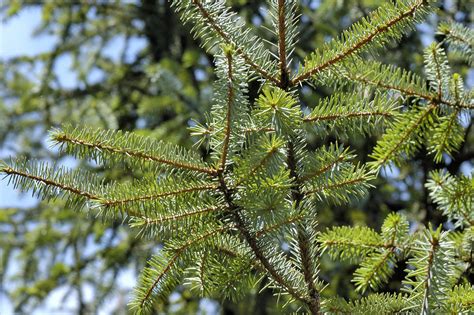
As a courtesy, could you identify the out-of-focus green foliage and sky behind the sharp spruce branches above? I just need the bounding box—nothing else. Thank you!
[0,0,474,314]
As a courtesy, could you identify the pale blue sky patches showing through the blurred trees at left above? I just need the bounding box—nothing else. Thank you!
[0,7,218,315]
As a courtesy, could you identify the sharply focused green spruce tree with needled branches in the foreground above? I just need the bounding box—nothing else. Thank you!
[0,0,474,314]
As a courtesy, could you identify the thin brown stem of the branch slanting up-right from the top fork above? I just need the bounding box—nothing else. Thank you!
[291,0,427,86]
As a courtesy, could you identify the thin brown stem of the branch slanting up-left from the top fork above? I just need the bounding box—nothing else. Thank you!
[192,0,279,85]
